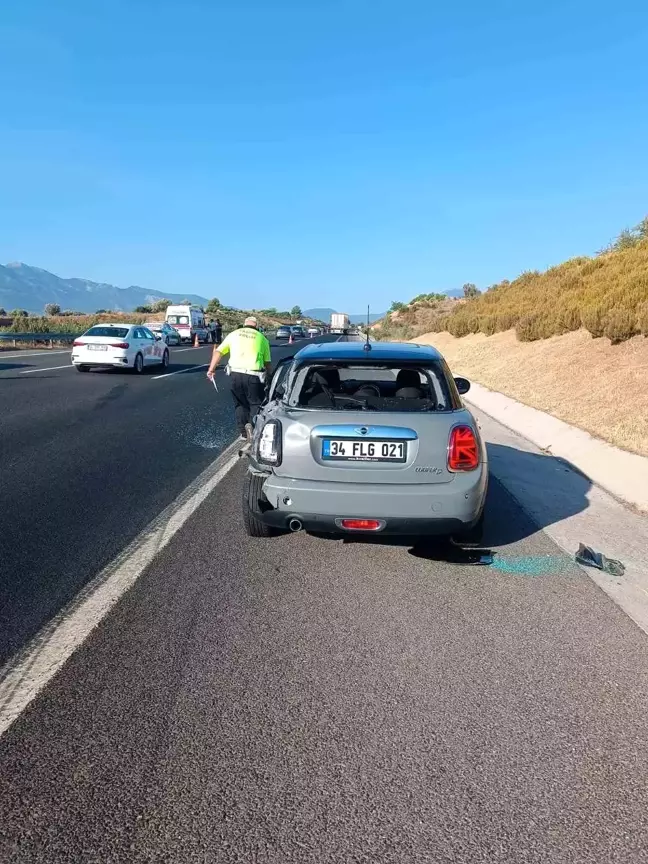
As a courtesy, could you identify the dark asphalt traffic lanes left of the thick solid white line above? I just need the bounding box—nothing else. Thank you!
[0,336,337,665]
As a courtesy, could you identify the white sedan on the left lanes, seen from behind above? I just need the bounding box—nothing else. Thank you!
[72,324,169,374]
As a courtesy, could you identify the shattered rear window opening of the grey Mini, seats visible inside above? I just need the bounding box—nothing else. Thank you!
[288,363,455,411]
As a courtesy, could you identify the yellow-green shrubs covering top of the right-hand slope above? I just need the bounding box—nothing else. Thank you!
[374,217,648,344]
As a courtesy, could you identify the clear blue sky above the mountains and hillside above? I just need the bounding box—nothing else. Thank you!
[0,0,648,312]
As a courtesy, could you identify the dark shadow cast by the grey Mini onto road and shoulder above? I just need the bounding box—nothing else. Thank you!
[310,443,592,564]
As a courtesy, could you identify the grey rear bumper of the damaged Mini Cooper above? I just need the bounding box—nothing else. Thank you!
[253,465,488,535]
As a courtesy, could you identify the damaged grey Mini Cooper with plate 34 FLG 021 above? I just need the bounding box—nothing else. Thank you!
[243,342,488,545]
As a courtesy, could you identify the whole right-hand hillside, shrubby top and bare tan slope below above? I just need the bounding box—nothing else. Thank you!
[374,218,648,456]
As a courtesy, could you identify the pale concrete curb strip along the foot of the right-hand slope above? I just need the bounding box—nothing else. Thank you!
[466,382,648,512]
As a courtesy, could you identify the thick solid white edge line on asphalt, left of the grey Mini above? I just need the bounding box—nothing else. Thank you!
[0,441,240,736]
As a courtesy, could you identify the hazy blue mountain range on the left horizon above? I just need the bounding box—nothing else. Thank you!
[0,263,207,315]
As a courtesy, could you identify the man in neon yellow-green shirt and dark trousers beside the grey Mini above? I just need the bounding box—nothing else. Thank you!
[207,315,270,440]
